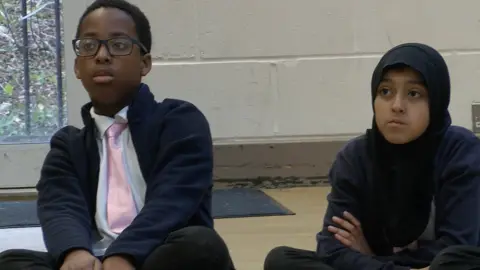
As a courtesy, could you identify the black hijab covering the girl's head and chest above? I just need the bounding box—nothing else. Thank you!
[367,43,451,255]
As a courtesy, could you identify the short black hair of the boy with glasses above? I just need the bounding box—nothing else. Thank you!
[75,0,152,53]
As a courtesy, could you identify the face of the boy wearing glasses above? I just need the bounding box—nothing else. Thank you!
[75,8,152,109]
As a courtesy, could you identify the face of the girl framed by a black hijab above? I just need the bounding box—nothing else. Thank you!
[373,67,430,144]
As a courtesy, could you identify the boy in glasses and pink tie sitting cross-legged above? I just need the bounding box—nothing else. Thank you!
[0,0,233,270]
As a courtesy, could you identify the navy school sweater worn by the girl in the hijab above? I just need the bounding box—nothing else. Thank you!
[317,126,480,270]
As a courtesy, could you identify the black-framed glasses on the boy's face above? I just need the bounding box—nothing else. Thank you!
[72,37,147,57]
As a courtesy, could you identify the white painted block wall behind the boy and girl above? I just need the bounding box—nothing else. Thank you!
[0,0,480,187]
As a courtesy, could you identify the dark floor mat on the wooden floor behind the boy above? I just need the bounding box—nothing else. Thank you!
[0,188,295,228]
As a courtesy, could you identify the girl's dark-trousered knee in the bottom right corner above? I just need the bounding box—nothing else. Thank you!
[430,246,480,270]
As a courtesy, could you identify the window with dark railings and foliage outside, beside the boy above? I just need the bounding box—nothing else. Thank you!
[0,0,67,144]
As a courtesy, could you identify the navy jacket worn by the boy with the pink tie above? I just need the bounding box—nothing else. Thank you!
[37,84,213,267]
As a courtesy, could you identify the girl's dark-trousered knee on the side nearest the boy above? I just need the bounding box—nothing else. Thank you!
[263,246,334,270]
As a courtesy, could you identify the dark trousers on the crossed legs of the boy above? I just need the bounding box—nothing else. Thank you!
[0,226,235,270]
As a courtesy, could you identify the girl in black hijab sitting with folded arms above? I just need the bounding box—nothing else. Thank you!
[265,43,480,270]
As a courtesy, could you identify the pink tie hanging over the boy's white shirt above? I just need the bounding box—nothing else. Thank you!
[106,123,137,234]
